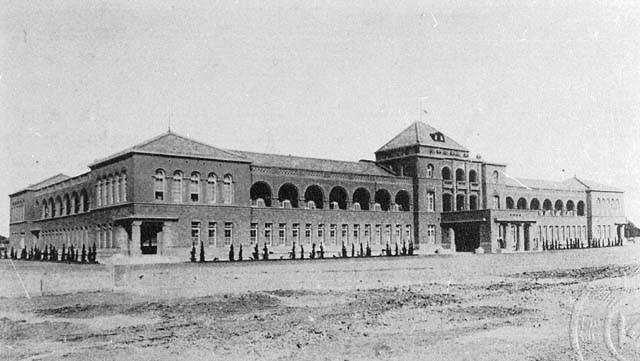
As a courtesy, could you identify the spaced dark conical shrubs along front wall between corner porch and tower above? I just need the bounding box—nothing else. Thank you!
[190,241,414,262]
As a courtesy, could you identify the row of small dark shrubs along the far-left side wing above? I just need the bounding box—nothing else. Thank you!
[4,243,98,263]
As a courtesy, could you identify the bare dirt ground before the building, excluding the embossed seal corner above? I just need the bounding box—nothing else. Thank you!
[0,247,640,361]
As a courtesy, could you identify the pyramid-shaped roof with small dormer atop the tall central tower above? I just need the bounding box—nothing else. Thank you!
[378,122,469,152]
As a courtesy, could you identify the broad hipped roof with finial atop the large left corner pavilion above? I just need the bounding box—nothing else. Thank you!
[90,131,248,167]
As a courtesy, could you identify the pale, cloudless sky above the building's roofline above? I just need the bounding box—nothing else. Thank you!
[0,0,640,235]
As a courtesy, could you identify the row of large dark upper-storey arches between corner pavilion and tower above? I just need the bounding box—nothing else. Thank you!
[249,181,411,211]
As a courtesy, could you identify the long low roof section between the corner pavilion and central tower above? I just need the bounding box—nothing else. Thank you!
[233,150,394,176]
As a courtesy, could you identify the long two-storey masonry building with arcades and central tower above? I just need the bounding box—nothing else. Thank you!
[10,122,626,259]
